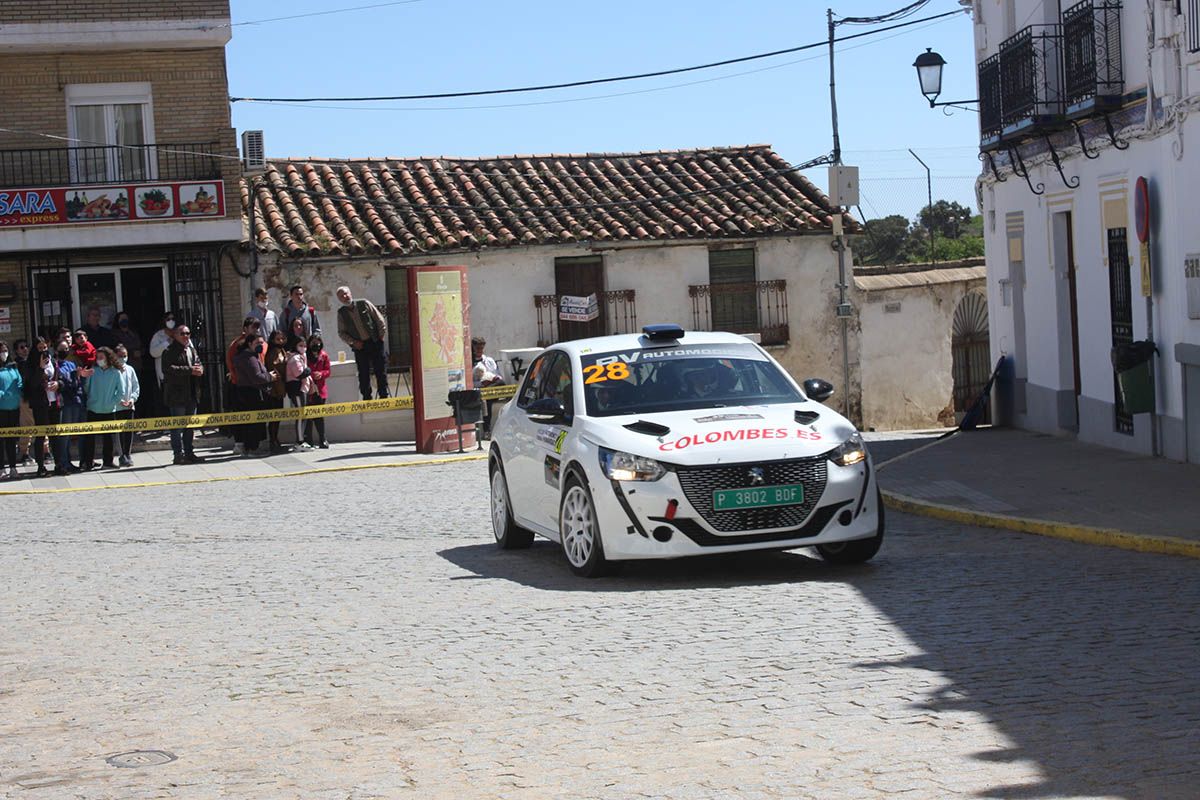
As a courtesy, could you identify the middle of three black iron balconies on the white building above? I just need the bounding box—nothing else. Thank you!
[1000,25,1063,133]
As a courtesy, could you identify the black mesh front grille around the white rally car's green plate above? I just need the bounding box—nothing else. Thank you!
[674,456,828,533]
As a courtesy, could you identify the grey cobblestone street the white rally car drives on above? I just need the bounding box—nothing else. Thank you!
[0,461,1200,800]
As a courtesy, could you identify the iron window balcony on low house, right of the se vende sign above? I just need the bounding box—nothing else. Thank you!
[688,281,788,344]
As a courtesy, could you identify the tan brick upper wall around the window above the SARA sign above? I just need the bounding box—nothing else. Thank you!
[0,48,241,224]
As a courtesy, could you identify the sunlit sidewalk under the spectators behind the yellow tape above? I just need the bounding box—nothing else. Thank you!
[0,434,486,495]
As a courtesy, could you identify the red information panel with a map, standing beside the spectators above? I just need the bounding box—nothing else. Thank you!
[408,266,474,452]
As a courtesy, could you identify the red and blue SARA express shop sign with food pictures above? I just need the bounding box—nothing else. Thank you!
[0,181,224,228]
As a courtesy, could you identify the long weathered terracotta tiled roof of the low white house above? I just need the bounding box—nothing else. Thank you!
[241,145,857,258]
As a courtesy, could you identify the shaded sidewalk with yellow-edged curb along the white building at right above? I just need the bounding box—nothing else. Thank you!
[869,428,1200,558]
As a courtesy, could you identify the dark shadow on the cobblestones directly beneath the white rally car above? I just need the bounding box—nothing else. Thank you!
[438,539,876,593]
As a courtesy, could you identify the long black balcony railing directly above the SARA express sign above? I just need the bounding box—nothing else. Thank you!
[0,142,222,188]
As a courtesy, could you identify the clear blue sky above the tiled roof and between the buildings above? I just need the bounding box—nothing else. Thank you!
[228,0,979,217]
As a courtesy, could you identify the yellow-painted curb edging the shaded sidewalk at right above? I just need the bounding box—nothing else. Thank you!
[883,489,1200,559]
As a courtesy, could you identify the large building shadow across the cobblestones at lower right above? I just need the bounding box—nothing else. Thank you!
[847,515,1200,800]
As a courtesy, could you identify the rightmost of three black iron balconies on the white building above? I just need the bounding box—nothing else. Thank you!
[1062,0,1124,116]
